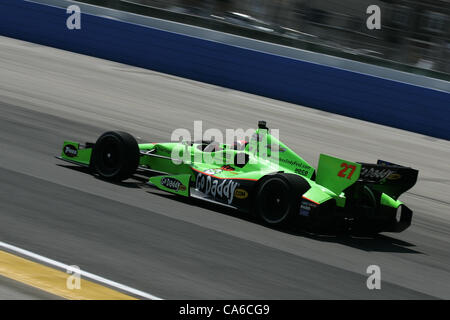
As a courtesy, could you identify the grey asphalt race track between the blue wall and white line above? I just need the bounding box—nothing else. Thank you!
[0,38,450,299]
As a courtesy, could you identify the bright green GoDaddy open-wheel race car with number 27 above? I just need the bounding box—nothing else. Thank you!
[58,121,418,234]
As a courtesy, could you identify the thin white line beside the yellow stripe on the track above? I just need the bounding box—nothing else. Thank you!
[0,241,163,300]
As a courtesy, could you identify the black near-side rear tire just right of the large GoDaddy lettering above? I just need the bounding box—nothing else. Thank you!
[255,173,310,227]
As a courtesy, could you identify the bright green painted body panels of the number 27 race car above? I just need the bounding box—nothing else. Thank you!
[61,129,401,208]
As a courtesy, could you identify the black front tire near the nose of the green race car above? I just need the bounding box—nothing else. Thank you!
[90,131,139,181]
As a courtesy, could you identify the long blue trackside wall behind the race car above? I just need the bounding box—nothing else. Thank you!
[0,0,450,140]
